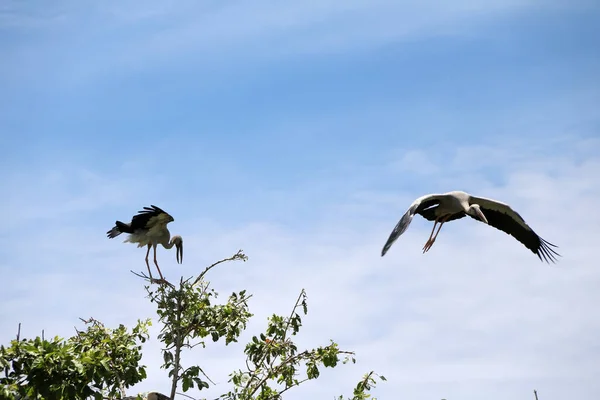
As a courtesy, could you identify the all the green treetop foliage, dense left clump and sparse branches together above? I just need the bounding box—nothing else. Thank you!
[0,250,385,400]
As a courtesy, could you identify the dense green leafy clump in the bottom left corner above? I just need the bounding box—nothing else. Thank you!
[0,319,150,399]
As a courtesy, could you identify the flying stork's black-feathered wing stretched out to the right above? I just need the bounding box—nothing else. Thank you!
[470,196,560,263]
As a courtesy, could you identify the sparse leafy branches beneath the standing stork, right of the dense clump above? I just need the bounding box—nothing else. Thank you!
[147,251,382,400]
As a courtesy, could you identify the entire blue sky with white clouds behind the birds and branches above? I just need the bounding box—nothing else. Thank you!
[0,0,600,400]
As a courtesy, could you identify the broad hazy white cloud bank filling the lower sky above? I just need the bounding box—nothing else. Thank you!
[0,135,600,400]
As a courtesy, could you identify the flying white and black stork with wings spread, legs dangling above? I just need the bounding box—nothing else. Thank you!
[381,191,560,263]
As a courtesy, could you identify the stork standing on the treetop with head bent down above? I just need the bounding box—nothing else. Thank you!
[106,206,183,280]
